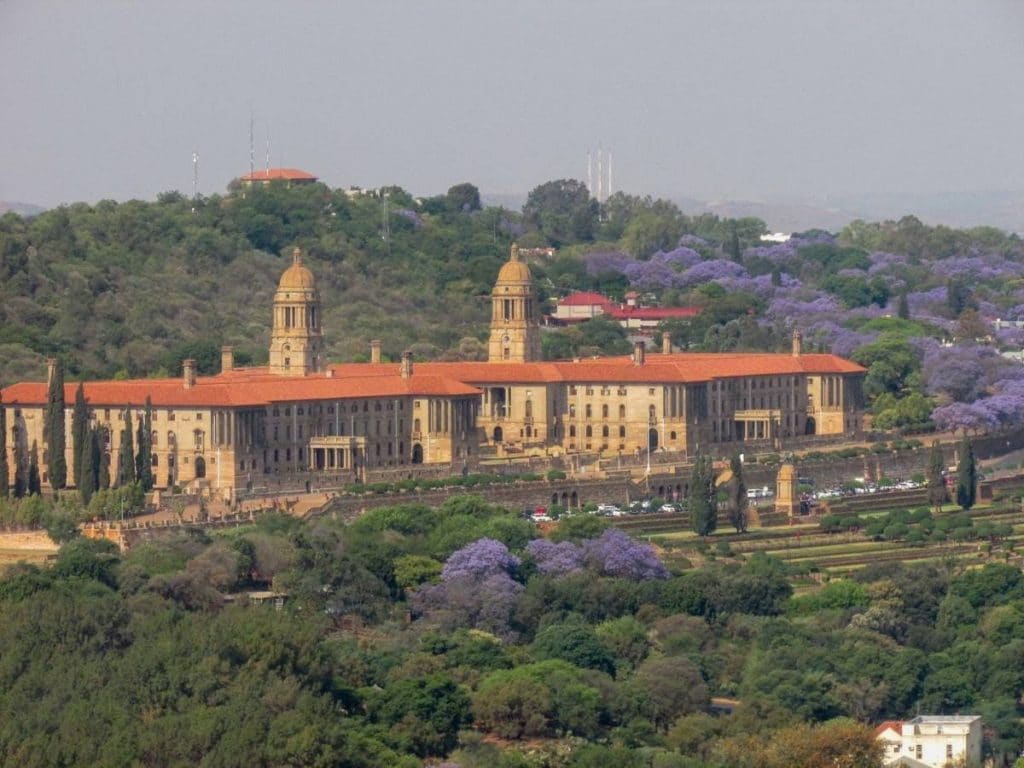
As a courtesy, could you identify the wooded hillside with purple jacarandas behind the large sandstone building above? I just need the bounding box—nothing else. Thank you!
[0,180,1024,430]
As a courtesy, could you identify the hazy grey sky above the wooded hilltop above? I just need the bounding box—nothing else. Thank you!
[0,0,1024,205]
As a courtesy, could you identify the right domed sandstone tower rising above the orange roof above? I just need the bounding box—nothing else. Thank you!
[487,244,541,362]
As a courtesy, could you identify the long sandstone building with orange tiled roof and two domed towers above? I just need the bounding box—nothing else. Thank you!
[2,247,864,498]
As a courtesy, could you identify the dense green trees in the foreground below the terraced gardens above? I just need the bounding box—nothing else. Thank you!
[0,497,1024,768]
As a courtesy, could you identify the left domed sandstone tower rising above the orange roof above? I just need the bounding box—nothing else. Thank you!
[270,248,324,376]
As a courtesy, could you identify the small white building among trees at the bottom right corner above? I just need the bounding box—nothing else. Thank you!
[874,715,982,768]
